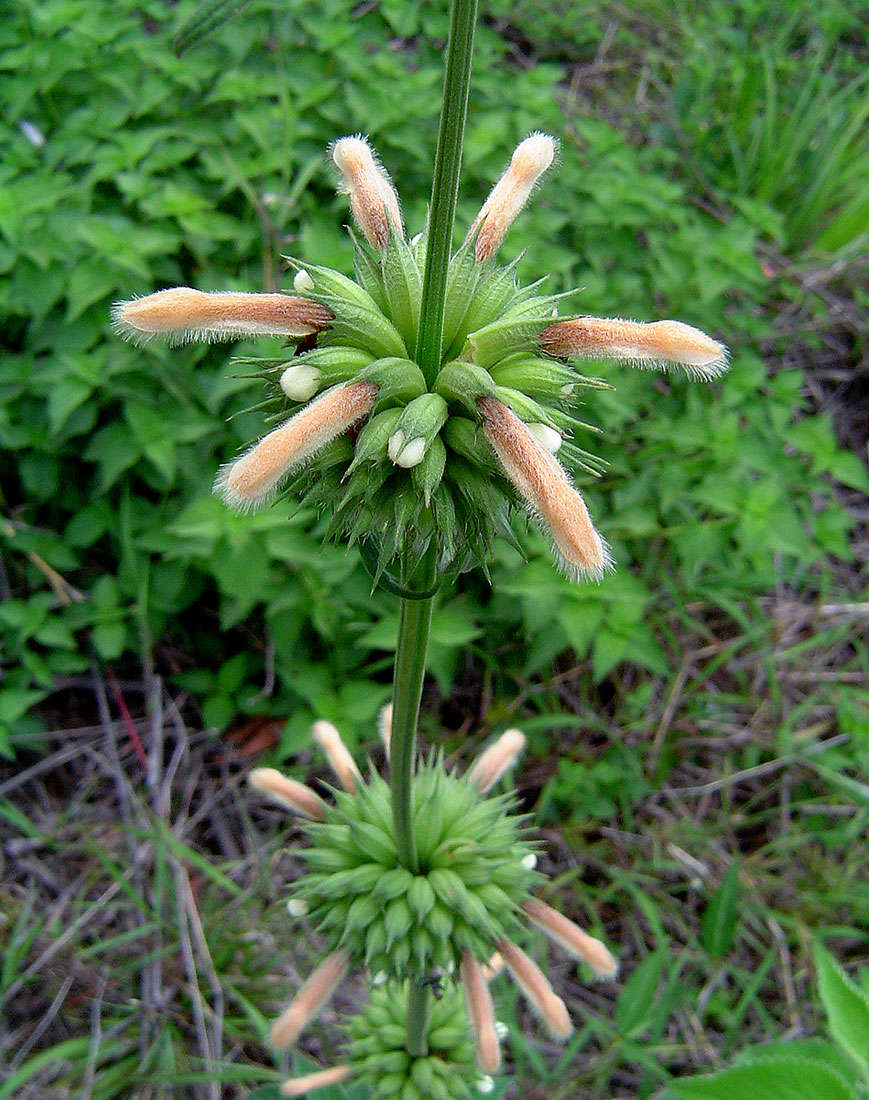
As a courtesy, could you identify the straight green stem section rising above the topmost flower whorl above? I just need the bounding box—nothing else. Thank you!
[416,0,477,386]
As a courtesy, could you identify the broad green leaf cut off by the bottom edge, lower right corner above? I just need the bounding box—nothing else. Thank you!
[669,1057,858,1100]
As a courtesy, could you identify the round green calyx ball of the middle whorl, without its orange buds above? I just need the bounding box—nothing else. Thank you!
[294,759,542,978]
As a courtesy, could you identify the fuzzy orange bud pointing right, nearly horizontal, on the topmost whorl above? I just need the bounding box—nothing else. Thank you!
[540,317,727,380]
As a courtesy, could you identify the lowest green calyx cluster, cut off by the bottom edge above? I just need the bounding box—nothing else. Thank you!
[347,981,480,1100]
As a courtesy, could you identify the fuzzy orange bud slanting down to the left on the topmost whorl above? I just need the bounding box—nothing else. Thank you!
[215,382,377,510]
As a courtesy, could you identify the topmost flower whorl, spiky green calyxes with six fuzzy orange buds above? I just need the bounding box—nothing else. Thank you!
[112,133,727,579]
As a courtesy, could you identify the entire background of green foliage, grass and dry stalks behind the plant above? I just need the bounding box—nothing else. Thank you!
[0,0,869,1098]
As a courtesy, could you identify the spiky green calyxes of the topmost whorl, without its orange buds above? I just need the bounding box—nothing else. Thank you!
[248,233,603,573]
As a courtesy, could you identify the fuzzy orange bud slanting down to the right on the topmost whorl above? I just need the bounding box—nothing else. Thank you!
[477,397,609,578]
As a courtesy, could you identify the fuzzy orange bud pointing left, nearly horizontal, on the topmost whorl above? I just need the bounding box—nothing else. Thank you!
[111,286,332,343]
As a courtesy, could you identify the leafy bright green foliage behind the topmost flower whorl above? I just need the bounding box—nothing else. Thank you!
[0,0,867,761]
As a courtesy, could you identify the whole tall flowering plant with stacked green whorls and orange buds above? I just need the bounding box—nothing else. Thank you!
[113,0,726,1100]
